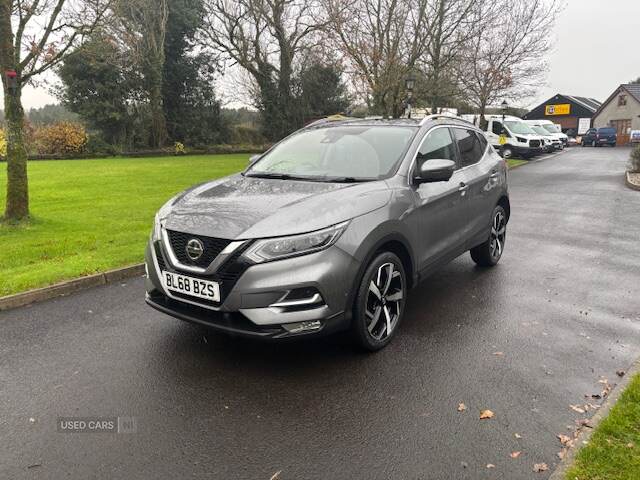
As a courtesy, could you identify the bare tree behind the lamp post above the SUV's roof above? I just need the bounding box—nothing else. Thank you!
[326,0,431,117]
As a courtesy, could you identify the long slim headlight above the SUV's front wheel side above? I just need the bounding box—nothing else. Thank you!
[242,222,349,263]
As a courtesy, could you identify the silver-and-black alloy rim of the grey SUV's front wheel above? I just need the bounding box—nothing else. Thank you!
[365,262,404,341]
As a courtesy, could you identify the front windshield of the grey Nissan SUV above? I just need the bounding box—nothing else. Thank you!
[245,125,417,181]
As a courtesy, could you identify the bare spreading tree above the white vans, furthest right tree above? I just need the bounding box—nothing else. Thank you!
[457,0,561,121]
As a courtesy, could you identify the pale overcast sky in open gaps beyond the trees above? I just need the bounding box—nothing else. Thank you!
[23,0,640,108]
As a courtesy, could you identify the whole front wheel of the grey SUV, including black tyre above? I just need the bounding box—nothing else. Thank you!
[351,252,407,352]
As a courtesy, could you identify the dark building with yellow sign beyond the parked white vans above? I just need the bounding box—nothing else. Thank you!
[523,93,600,135]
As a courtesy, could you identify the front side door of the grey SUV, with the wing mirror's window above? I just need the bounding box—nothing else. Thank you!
[411,126,468,270]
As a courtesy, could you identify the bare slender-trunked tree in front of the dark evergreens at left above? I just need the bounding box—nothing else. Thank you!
[112,0,169,148]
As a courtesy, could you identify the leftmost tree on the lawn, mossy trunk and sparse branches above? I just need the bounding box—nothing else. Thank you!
[0,0,109,220]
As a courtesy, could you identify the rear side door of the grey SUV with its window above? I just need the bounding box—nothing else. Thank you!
[452,127,505,242]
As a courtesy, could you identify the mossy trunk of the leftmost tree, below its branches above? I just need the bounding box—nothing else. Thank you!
[4,83,29,220]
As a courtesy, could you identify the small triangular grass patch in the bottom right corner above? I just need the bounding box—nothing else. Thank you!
[566,375,640,480]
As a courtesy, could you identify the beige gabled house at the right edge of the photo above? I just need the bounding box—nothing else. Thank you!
[593,83,640,145]
